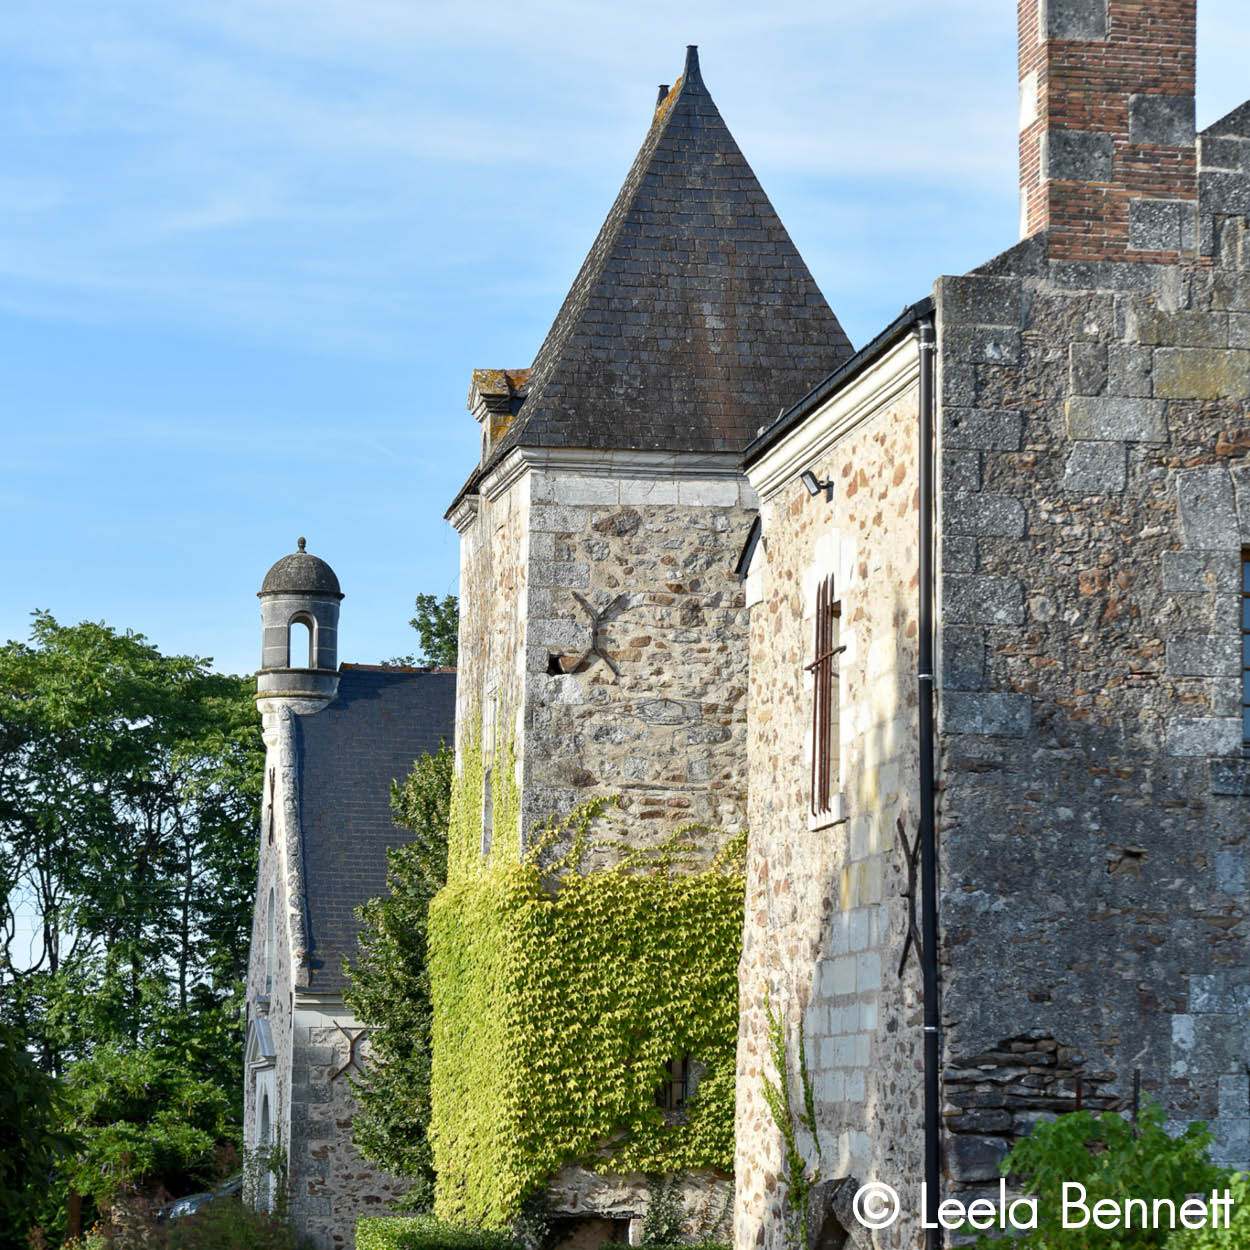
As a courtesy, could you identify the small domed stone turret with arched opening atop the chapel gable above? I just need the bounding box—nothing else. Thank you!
[256,538,343,715]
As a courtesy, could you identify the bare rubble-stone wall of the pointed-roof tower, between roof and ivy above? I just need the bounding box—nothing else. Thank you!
[459,454,755,860]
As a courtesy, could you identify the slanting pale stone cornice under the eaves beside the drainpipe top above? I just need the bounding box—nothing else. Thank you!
[746,335,920,501]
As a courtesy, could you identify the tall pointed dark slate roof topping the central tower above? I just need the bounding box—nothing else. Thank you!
[490,48,851,460]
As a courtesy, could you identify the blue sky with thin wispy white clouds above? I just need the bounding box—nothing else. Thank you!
[0,0,1250,671]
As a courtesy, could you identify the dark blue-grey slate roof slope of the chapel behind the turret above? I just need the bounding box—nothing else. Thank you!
[295,664,456,994]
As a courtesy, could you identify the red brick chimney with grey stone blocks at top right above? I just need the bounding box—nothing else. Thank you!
[1019,0,1198,263]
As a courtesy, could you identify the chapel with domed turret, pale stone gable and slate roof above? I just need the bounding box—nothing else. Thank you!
[244,539,455,1250]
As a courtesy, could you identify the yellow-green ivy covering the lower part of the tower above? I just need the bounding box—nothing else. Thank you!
[430,736,745,1228]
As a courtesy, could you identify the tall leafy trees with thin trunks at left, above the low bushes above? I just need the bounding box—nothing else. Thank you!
[0,613,264,1084]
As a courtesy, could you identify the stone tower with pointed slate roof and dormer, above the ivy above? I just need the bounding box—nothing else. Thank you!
[448,48,851,854]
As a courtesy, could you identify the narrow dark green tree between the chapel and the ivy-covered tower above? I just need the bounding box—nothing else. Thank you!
[346,746,455,1210]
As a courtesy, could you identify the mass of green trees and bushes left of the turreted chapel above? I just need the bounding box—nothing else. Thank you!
[0,613,264,1240]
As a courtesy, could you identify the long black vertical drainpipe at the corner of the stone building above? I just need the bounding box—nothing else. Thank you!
[916,315,943,1250]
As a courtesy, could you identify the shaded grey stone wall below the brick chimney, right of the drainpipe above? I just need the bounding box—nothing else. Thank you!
[936,218,1250,1186]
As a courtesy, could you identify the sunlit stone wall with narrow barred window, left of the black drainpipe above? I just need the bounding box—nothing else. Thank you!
[734,338,923,1248]
